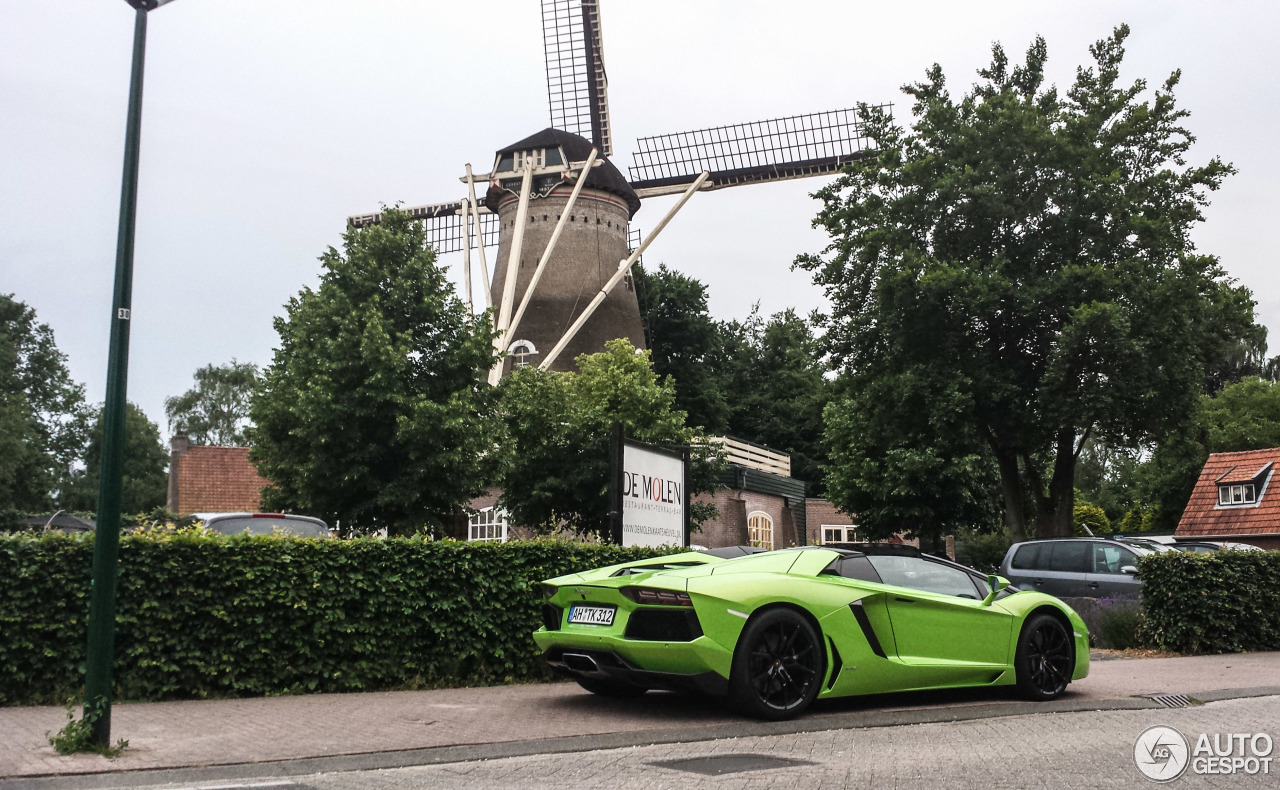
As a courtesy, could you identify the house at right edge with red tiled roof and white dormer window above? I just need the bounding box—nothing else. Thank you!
[1174,448,1280,549]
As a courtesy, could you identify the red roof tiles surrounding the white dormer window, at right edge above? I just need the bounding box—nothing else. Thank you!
[1174,447,1280,538]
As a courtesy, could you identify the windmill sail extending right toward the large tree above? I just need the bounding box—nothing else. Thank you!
[628,105,891,198]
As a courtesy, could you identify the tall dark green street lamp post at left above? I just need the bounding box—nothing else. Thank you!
[84,0,179,746]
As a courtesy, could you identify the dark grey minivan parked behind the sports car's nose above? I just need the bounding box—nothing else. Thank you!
[1000,538,1152,598]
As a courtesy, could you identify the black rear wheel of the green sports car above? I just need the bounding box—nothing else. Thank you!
[728,608,827,721]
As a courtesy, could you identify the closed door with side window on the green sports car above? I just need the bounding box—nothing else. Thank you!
[868,554,1012,682]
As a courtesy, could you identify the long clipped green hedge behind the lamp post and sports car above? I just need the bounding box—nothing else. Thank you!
[0,531,670,704]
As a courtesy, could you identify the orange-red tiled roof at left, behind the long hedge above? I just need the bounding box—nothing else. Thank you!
[170,446,266,513]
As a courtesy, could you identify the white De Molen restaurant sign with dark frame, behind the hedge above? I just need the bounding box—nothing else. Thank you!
[609,425,689,547]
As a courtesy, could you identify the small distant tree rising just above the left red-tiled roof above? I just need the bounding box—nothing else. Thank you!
[164,360,261,447]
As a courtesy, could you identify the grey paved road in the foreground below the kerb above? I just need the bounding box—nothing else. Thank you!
[17,697,1280,790]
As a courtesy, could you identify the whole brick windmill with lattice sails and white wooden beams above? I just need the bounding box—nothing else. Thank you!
[348,0,890,383]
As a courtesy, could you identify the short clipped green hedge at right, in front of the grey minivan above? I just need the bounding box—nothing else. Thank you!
[1138,552,1280,653]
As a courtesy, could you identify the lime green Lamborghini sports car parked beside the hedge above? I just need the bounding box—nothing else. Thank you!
[534,544,1089,720]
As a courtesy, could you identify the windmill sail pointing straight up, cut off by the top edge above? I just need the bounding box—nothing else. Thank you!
[543,0,613,156]
